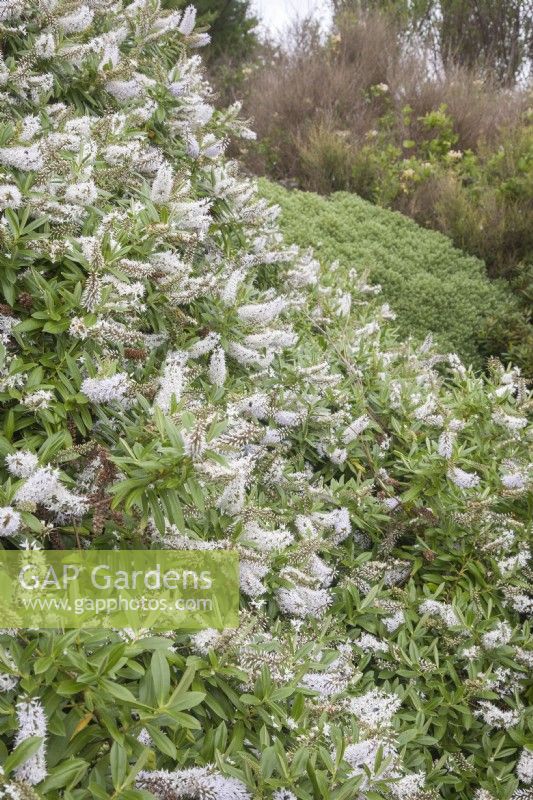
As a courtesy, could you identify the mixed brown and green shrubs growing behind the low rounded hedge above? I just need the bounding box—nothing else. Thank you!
[235,9,533,374]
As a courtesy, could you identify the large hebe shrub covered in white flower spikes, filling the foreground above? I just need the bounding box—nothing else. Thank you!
[0,0,533,800]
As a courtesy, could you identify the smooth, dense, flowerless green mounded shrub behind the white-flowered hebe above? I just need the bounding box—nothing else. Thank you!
[261,180,512,365]
